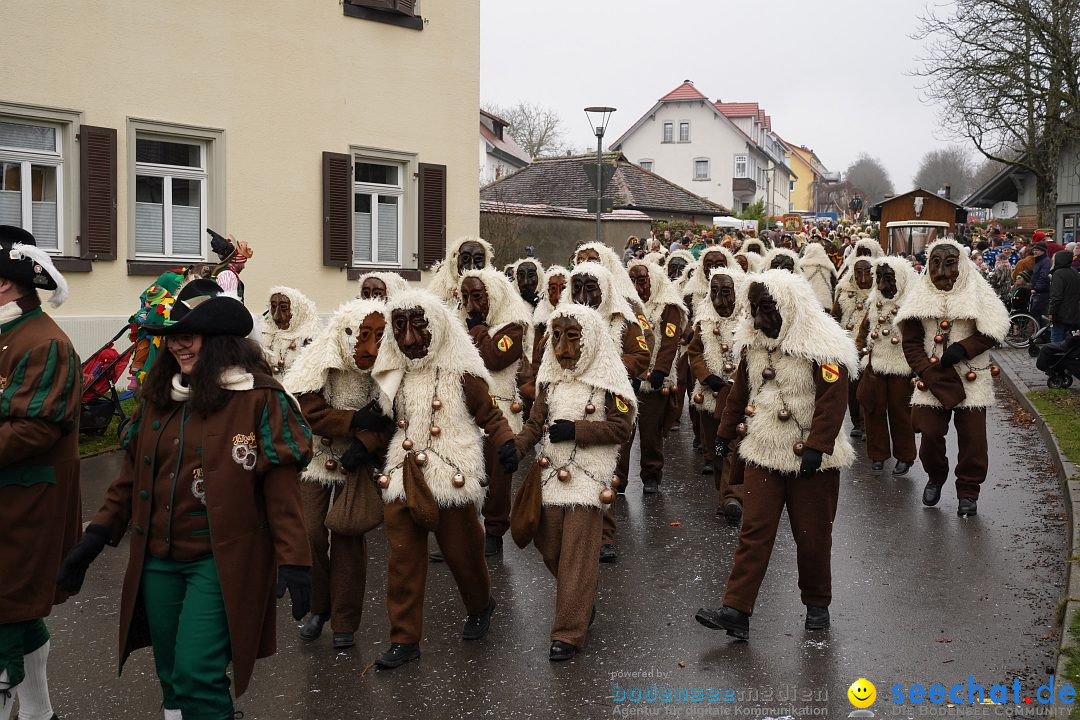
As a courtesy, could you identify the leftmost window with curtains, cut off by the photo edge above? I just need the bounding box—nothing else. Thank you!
[0,119,64,254]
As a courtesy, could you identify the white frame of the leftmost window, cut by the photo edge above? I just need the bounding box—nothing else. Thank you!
[0,103,82,257]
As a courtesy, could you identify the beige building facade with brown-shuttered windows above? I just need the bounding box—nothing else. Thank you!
[0,0,480,354]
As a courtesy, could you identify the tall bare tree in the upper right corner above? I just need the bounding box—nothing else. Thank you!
[915,0,1080,223]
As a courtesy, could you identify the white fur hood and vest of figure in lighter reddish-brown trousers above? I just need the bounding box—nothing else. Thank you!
[537,303,636,507]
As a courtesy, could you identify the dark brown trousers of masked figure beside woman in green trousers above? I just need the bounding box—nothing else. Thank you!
[300,481,367,633]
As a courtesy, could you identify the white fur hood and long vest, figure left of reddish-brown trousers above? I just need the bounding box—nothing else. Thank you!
[372,288,491,507]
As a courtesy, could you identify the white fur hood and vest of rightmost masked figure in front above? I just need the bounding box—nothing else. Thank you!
[896,240,1009,409]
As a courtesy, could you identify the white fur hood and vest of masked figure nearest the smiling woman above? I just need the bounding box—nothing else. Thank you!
[284,300,394,486]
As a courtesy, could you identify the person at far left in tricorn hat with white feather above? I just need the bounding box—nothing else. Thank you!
[0,226,82,720]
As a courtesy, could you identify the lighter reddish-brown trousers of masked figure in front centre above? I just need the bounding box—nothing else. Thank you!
[534,505,603,648]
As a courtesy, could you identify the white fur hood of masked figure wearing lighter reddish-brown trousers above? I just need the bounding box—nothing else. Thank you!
[537,303,637,406]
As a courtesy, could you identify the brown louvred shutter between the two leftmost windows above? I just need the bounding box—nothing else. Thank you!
[79,125,117,260]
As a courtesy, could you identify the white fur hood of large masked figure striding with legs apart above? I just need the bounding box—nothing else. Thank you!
[734,270,859,380]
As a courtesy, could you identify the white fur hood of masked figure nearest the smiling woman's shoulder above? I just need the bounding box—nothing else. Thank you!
[283,300,395,395]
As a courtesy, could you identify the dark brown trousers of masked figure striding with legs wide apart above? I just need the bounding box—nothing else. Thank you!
[724,464,840,615]
